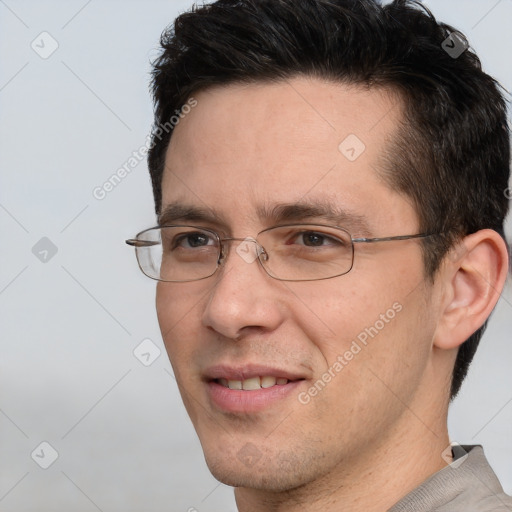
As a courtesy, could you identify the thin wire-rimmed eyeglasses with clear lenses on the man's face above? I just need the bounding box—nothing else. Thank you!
[126,224,432,283]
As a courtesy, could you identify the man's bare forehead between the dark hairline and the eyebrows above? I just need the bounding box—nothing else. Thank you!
[162,77,414,232]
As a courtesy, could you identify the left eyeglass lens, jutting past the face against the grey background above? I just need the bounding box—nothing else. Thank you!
[136,226,220,282]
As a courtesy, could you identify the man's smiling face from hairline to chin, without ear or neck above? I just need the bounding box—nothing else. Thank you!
[157,78,444,490]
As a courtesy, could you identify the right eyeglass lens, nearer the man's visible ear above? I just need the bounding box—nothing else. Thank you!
[258,224,354,281]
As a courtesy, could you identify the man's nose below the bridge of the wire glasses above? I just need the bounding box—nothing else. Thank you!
[202,238,284,339]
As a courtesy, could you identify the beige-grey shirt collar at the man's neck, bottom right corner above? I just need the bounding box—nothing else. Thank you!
[388,446,512,512]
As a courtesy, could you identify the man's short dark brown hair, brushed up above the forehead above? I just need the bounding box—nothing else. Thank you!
[148,0,510,398]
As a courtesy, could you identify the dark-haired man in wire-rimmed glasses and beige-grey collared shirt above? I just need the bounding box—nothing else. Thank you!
[125,0,512,512]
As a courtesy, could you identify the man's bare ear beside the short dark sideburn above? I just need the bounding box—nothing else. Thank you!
[434,229,509,349]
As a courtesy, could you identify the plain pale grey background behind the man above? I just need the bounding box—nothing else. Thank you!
[0,0,512,512]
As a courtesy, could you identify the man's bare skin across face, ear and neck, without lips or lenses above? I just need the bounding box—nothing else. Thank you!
[157,77,506,512]
